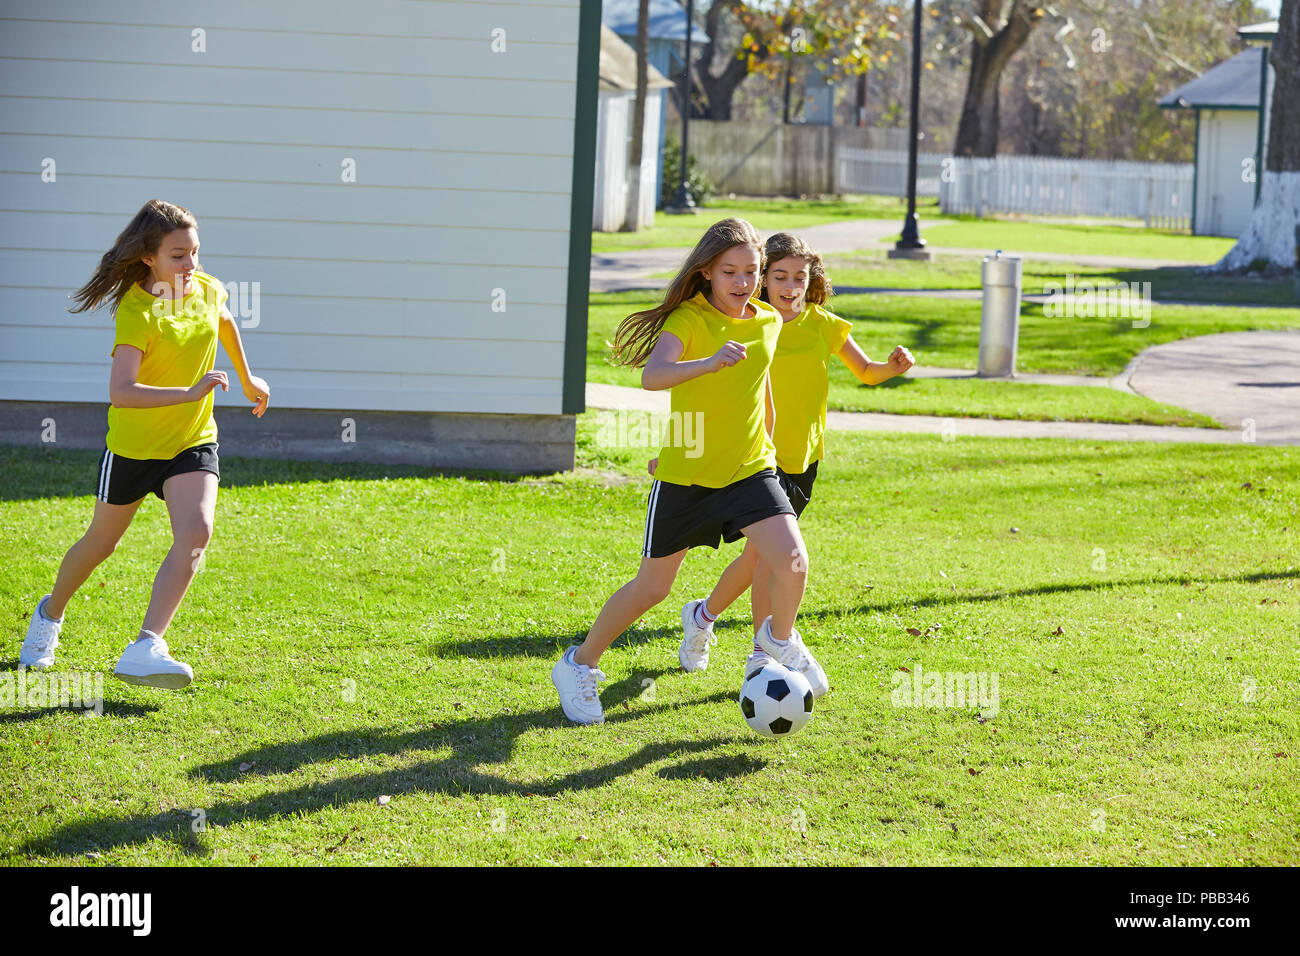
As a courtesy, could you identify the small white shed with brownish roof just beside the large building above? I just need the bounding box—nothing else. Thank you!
[592,23,672,233]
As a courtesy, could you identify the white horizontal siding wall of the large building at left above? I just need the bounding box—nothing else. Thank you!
[0,0,586,414]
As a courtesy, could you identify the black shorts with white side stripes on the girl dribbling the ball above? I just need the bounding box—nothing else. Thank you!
[641,468,794,558]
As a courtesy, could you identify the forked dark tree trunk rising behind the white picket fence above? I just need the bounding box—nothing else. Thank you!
[953,0,1043,156]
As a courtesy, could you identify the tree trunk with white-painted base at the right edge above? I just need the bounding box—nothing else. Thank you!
[1212,0,1300,272]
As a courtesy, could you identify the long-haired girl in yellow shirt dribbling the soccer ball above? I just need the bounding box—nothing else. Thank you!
[551,219,826,723]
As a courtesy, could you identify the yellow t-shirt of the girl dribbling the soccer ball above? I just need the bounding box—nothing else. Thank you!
[655,293,781,488]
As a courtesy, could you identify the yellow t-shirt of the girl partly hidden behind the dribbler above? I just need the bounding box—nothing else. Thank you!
[772,304,853,475]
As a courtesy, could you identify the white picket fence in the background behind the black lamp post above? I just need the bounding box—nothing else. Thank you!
[836,148,1192,229]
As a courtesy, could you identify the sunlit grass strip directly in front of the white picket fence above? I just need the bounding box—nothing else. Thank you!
[881,219,1235,264]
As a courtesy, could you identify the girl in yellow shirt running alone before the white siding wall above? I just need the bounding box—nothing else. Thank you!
[20,199,270,689]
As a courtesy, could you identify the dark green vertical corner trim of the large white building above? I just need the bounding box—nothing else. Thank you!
[560,0,601,415]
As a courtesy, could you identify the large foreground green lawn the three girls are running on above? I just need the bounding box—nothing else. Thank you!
[0,434,1300,866]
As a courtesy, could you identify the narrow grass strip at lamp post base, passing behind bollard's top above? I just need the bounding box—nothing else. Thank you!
[826,251,1300,308]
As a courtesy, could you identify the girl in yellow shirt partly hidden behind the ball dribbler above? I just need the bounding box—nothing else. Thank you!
[679,233,914,671]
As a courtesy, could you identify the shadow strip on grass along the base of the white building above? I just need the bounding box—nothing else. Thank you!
[0,445,546,501]
